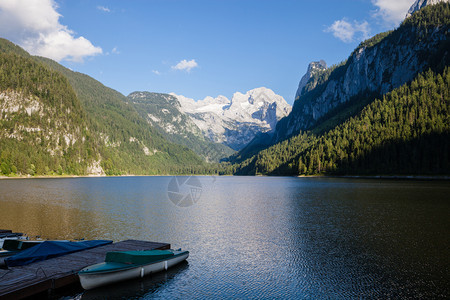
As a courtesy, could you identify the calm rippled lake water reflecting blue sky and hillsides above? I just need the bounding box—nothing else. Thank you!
[0,177,450,299]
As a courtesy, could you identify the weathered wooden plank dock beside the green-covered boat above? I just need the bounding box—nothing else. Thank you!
[0,240,170,300]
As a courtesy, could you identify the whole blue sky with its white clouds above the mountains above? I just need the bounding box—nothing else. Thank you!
[0,0,414,104]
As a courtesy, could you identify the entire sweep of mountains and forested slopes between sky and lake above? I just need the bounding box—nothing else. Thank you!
[0,2,450,176]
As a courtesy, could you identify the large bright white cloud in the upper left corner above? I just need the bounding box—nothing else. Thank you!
[0,0,102,62]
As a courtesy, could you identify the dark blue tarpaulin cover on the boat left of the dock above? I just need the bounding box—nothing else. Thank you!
[5,240,112,267]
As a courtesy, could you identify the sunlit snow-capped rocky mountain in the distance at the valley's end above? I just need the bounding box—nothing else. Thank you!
[171,87,291,150]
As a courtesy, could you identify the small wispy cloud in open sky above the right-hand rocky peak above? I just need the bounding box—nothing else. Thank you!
[325,18,370,43]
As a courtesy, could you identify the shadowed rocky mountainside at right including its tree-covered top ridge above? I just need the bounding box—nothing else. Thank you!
[274,3,450,142]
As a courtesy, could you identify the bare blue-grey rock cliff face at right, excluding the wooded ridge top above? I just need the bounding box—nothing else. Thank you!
[275,9,449,141]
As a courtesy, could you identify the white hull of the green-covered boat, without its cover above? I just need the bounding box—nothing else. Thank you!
[78,252,189,290]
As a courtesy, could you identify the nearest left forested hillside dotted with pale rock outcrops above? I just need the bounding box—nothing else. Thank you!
[0,40,98,175]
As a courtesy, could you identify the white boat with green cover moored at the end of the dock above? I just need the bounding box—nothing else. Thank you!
[78,249,189,290]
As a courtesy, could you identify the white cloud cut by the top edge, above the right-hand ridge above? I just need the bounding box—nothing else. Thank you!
[372,0,414,26]
